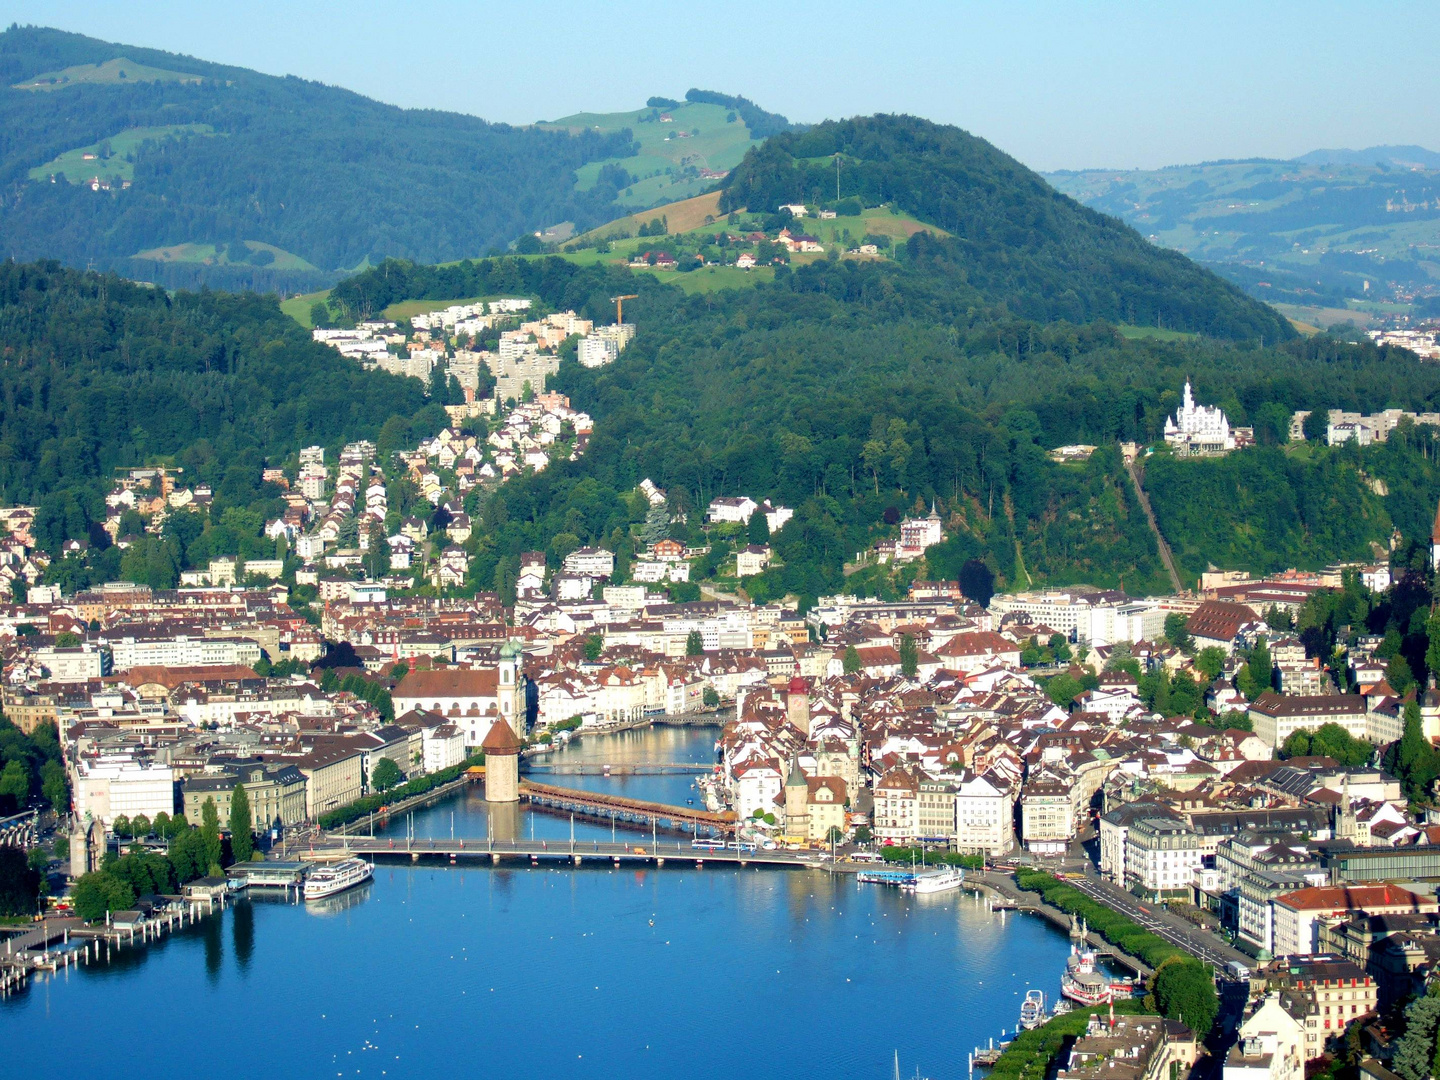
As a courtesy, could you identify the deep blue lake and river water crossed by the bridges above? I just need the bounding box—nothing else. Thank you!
[0,727,1067,1080]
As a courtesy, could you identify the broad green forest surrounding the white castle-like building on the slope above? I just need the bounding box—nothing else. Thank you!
[331,252,1440,610]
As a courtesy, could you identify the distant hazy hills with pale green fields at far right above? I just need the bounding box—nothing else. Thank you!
[1045,154,1440,325]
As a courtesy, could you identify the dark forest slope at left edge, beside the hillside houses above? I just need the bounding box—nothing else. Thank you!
[0,262,426,552]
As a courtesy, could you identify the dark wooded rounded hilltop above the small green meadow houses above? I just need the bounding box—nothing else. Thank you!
[721,117,1295,341]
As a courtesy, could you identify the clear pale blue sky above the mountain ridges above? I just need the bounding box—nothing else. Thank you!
[0,0,1440,168]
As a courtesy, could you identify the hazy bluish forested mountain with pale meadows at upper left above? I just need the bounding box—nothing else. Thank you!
[0,27,631,289]
